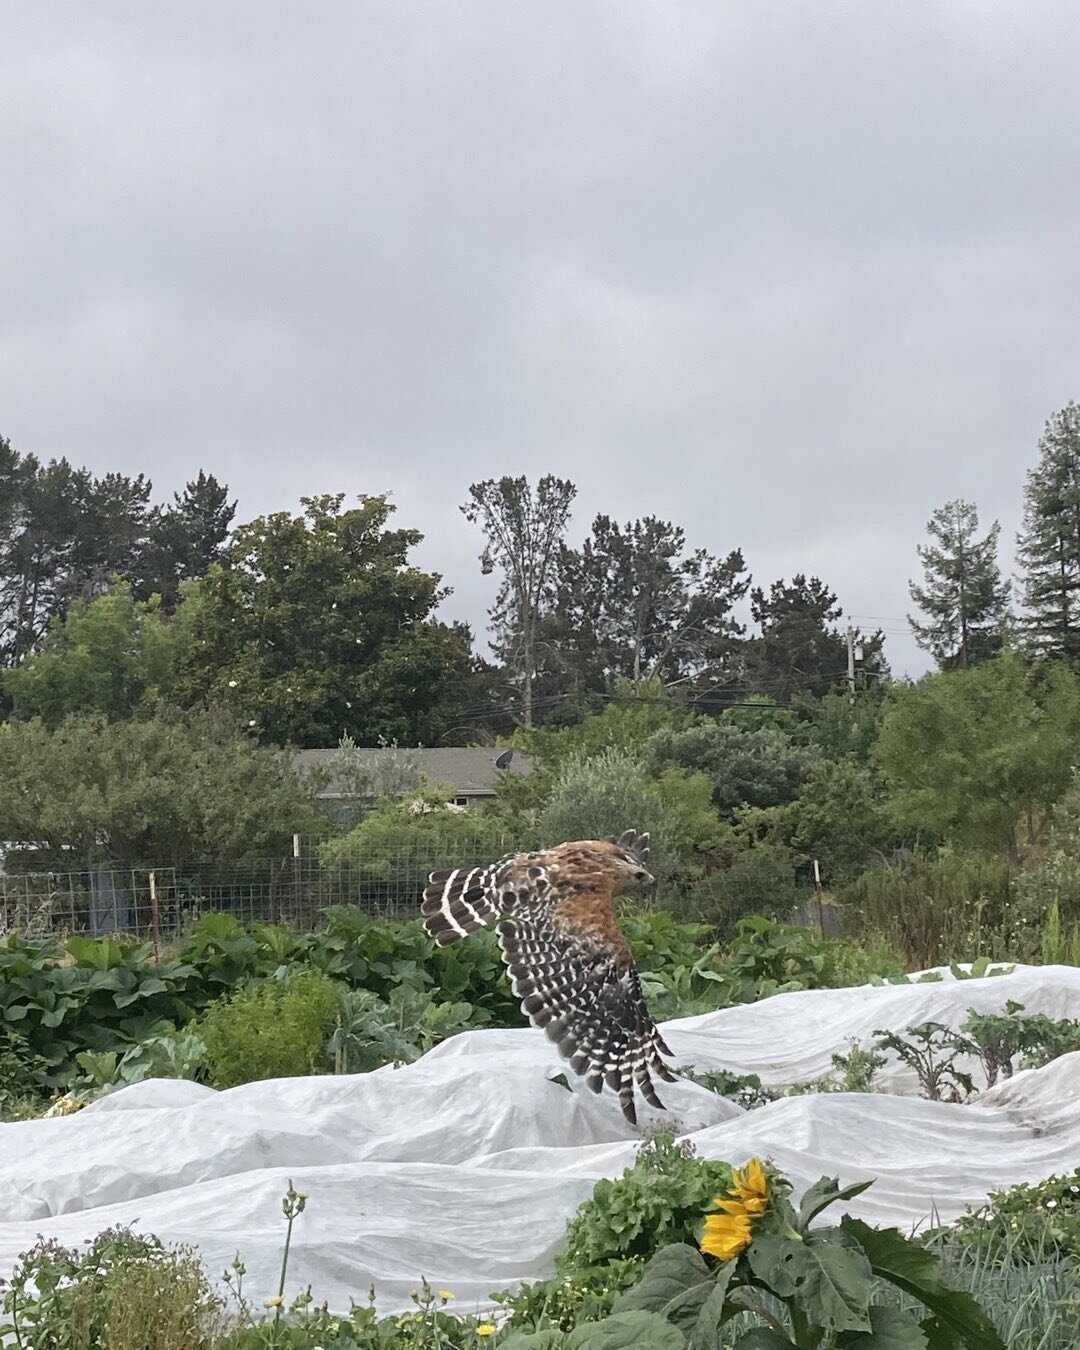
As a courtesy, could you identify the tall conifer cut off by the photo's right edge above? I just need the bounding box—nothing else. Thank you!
[1017,402,1080,662]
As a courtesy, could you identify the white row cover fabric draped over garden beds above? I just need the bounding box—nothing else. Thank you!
[0,967,1080,1312]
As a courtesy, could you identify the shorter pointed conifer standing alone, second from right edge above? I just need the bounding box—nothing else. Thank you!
[907,500,1010,670]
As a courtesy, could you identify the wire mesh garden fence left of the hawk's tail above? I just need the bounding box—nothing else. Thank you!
[0,829,527,940]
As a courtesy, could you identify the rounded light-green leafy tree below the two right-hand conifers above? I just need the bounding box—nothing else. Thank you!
[875,651,1080,859]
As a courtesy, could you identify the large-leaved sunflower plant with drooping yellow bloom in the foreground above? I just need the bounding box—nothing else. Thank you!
[614,1173,1004,1350]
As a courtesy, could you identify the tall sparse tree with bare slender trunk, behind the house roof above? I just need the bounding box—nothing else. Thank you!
[462,474,578,726]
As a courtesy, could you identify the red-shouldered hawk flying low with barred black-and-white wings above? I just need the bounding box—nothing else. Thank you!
[421,830,675,1125]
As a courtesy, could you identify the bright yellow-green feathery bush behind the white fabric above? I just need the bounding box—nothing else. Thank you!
[200,971,340,1088]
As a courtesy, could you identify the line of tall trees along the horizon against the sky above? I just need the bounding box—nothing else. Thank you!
[0,404,1080,747]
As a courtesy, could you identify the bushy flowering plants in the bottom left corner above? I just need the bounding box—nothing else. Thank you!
[0,1227,224,1350]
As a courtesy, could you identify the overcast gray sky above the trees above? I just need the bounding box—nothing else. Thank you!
[0,0,1080,674]
